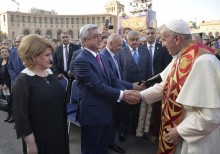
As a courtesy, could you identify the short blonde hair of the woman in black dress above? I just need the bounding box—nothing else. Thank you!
[18,34,54,68]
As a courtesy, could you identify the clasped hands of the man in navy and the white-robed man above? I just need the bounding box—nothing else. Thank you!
[122,90,141,104]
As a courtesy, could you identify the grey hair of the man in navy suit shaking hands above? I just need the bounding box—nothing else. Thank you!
[79,24,98,41]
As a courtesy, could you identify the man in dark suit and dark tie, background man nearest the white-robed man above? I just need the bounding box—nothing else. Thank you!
[145,27,172,142]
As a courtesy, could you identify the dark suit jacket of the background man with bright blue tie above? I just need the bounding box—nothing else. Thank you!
[119,46,151,83]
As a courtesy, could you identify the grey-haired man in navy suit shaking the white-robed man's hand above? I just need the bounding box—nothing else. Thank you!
[74,24,139,154]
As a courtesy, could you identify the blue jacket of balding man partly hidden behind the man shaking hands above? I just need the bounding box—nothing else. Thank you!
[100,48,133,89]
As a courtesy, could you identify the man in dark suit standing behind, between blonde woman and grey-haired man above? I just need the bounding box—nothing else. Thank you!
[53,32,80,79]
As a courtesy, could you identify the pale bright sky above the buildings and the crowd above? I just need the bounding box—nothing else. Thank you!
[0,0,220,26]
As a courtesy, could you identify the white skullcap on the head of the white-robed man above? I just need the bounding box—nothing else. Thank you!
[165,19,191,34]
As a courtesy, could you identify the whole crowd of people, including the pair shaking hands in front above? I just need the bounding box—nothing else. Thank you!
[0,20,220,154]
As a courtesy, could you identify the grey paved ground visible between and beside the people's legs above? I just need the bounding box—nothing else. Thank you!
[0,111,157,154]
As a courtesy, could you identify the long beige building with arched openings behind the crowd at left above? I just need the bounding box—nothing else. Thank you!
[0,0,124,40]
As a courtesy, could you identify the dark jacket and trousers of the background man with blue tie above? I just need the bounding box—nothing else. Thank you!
[119,46,151,133]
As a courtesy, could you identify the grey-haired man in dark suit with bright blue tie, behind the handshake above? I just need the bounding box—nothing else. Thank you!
[119,31,151,141]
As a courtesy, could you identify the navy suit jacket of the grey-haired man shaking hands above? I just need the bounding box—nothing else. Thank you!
[74,49,125,126]
